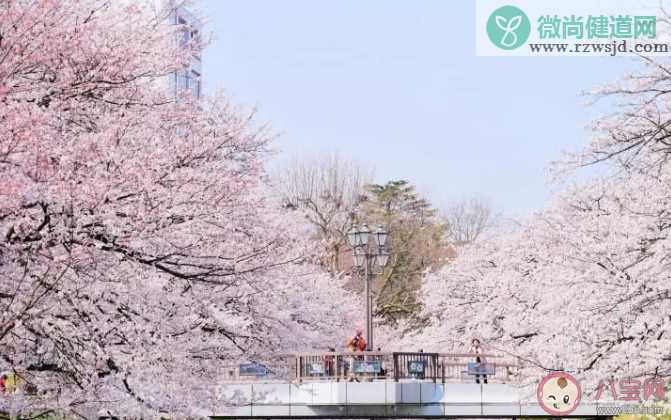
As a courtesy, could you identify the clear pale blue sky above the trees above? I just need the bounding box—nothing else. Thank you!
[197,0,637,216]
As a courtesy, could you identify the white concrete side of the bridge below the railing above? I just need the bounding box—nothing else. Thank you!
[220,381,598,419]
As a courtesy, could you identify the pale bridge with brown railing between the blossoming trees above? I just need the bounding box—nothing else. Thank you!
[218,352,608,419]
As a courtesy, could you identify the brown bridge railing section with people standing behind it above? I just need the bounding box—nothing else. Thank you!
[288,351,521,383]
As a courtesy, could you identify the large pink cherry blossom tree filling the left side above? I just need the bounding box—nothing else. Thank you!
[0,0,357,417]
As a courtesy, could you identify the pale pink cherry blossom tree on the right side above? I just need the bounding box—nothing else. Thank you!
[422,61,671,393]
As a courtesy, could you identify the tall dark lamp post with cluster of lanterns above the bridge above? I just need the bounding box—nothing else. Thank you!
[347,224,389,350]
